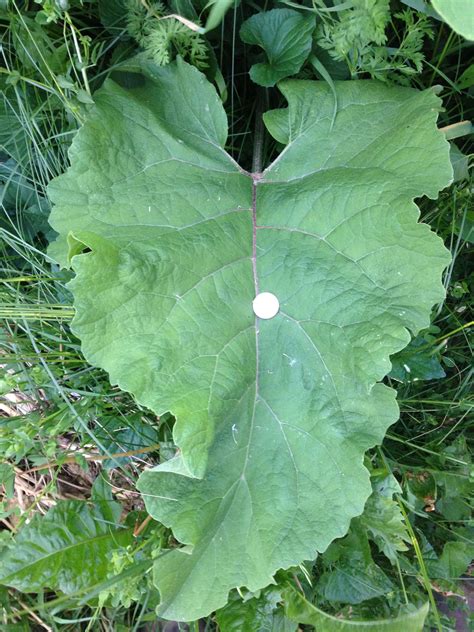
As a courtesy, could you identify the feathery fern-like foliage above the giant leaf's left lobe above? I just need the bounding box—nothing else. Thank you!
[127,0,209,70]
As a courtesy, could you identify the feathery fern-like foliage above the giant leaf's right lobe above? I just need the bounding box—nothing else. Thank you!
[316,0,432,85]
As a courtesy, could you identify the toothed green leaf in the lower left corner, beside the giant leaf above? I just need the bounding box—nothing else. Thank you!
[0,500,132,594]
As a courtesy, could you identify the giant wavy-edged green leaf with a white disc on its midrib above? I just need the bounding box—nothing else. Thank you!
[50,60,451,621]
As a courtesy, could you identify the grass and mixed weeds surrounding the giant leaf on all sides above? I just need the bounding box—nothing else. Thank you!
[0,0,474,632]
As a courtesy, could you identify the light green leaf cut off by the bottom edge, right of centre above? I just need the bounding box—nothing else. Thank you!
[284,589,429,632]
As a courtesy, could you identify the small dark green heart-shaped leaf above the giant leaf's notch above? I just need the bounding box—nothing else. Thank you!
[240,9,315,87]
